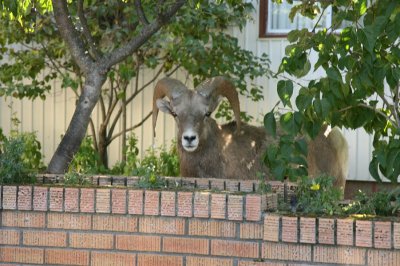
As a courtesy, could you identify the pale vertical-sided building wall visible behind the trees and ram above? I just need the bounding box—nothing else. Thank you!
[0,1,372,180]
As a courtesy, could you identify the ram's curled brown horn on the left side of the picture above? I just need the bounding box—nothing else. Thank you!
[153,78,187,136]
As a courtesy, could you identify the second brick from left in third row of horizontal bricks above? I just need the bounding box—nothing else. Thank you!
[45,249,89,265]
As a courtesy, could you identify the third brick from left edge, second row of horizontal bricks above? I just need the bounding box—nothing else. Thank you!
[69,233,114,249]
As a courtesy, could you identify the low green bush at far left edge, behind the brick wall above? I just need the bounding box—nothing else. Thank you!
[0,135,35,184]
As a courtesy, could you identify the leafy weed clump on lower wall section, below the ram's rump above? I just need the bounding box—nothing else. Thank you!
[296,176,343,215]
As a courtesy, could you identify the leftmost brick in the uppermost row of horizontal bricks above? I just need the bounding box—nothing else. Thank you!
[1,211,45,228]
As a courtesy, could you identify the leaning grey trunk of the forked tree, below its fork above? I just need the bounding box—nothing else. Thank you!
[47,70,106,174]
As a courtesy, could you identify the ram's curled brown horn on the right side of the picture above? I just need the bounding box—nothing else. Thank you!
[196,76,241,132]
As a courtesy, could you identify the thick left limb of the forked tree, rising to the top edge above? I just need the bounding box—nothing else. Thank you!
[52,0,93,73]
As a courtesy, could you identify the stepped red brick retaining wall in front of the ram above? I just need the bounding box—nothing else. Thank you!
[0,179,400,266]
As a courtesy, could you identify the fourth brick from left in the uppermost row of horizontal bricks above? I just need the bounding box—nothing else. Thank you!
[139,216,185,235]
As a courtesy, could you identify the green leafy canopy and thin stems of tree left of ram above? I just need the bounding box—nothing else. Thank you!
[0,0,269,172]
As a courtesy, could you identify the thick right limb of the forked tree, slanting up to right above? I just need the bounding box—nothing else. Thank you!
[101,0,187,68]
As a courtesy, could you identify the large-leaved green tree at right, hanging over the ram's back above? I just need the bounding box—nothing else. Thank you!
[265,0,400,182]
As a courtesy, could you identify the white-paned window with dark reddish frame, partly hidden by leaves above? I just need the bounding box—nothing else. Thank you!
[259,0,346,37]
